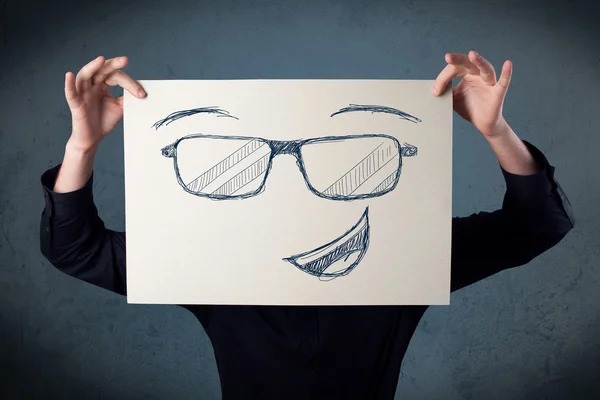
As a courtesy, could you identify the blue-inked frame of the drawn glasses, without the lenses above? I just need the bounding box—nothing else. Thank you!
[160,133,417,201]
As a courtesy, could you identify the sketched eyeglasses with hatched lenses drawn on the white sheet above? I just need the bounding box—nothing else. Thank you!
[161,134,417,201]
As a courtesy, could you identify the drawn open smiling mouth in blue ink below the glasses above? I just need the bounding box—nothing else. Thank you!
[283,207,369,281]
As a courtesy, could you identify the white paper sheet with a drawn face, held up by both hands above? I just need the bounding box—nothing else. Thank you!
[124,80,452,305]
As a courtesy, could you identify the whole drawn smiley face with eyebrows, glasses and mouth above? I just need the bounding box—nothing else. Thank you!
[153,104,421,281]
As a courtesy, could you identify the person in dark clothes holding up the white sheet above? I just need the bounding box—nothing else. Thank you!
[40,51,574,399]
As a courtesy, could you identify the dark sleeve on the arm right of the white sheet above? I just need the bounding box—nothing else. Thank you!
[451,141,575,291]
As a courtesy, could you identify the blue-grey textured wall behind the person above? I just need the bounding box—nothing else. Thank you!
[0,0,600,399]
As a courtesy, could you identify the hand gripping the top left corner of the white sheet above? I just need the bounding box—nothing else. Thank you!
[65,56,146,152]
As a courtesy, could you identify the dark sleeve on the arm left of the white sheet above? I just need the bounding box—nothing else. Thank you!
[40,165,126,295]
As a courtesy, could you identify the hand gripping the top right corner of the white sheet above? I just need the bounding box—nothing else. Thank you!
[432,50,512,139]
